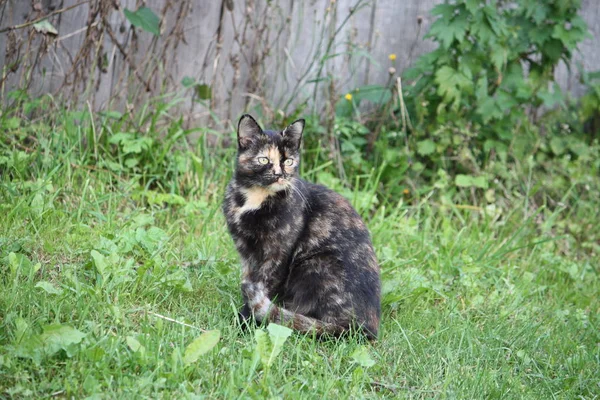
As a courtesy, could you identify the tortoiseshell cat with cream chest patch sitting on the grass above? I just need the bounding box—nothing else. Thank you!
[223,115,380,339]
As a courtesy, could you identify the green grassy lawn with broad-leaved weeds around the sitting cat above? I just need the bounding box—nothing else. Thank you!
[0,104,600,399]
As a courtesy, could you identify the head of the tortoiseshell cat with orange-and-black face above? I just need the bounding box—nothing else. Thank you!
[235,114,304,192]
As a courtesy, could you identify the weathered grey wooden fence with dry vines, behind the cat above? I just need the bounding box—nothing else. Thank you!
[0,0,600,125]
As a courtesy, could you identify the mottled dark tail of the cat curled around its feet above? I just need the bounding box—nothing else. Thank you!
[242,282,371,339]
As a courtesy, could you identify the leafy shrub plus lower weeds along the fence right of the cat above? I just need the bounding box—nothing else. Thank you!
[316,0,600,222]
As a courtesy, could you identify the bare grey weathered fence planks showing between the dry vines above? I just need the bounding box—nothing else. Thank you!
[0,0,600,120]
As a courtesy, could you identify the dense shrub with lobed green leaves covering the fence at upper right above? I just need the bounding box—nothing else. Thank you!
[405,0,589,143]
